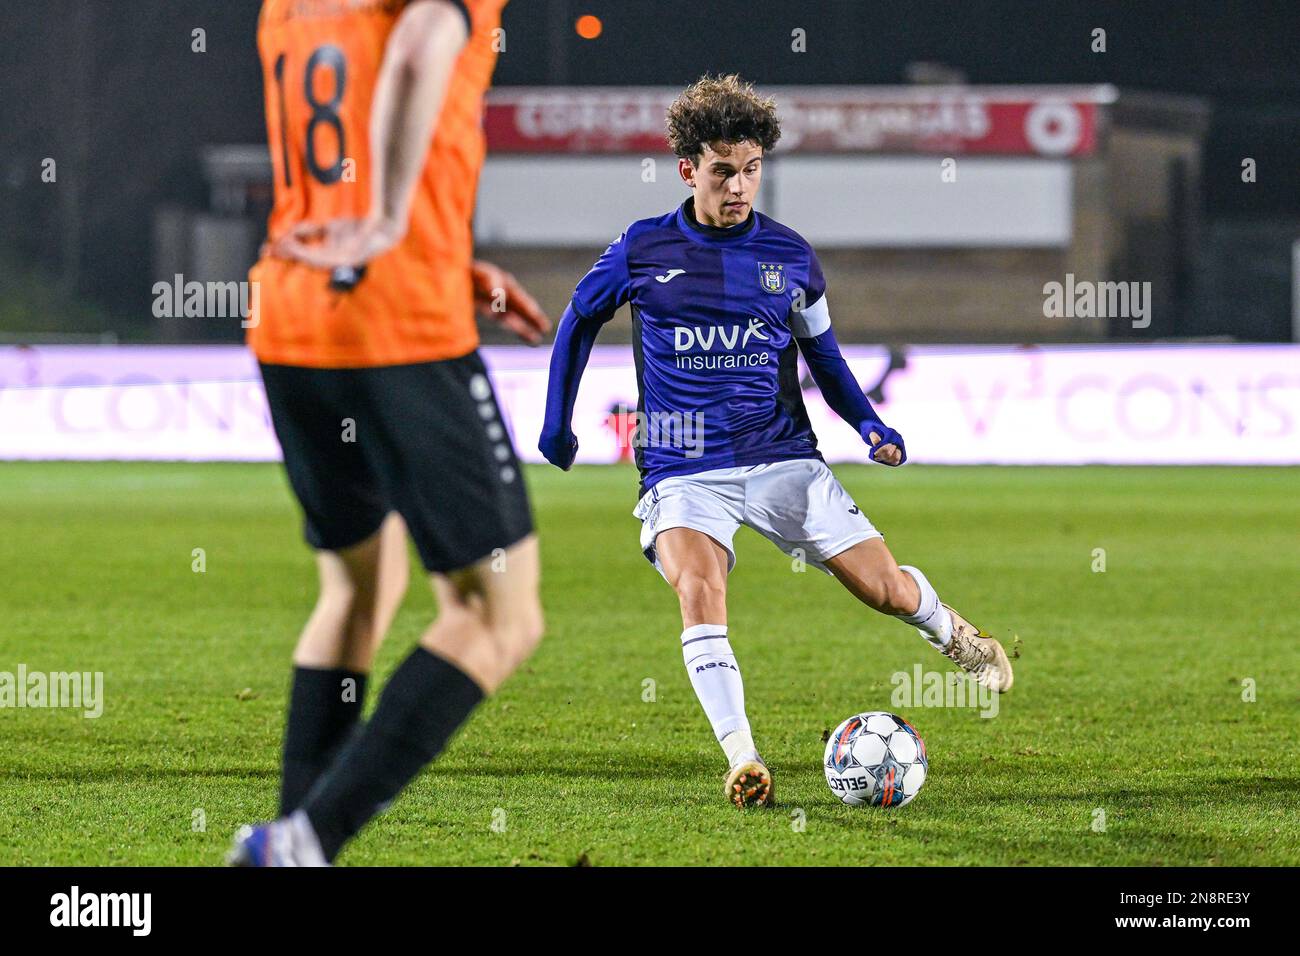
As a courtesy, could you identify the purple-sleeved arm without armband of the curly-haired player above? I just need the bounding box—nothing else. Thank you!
[537,234,631,471]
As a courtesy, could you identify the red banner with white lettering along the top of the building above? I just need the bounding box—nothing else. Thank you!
[484,87,1114,156]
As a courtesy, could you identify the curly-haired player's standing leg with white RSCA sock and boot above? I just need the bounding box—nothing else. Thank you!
[655,528,772,808]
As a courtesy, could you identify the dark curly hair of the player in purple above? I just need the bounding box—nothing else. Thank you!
[667,73,781,164]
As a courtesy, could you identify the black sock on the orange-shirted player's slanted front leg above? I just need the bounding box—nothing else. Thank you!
[303,646,484,860]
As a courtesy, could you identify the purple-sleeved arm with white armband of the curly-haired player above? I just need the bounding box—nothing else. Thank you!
[790,291,907,466]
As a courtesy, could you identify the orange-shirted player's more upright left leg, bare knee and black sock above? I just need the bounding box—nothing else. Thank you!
[280,514,410,814]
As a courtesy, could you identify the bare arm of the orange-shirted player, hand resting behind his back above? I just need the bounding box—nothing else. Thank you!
[276,0,469,269]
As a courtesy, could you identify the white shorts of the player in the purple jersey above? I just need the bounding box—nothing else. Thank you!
[632,458,884,574]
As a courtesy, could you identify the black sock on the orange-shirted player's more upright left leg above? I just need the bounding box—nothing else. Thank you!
[280,667,365,817]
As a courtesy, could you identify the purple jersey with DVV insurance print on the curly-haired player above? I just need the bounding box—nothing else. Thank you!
[572,200,829,492]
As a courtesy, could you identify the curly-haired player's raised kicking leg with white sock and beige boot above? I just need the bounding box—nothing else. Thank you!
[824,538,1014,693]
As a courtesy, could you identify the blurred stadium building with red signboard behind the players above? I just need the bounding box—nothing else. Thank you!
[165,86,1206,343]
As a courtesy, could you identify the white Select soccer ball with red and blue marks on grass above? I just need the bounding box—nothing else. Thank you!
[824,710,930,806]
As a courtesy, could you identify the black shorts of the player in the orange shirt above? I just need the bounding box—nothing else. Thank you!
[261,351,533,572]
